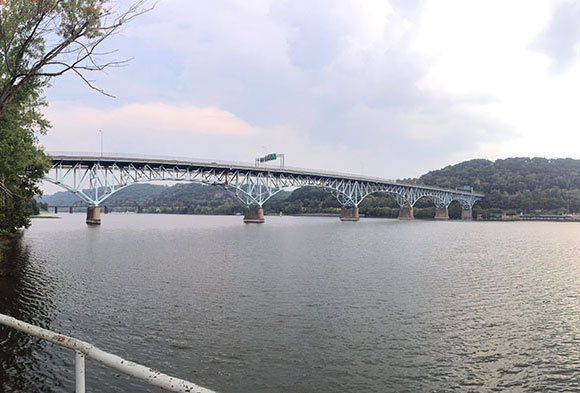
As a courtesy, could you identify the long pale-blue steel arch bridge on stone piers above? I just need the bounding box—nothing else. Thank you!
[45,153,484,224]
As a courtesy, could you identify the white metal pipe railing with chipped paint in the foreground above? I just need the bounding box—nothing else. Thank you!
[0,314,215,393]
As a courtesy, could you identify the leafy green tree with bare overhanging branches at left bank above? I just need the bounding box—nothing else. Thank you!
[0,0,149,232]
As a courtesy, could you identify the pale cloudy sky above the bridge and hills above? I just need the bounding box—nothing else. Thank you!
[40,0,580,179]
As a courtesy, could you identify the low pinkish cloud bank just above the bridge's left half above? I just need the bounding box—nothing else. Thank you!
[40,102,372,172]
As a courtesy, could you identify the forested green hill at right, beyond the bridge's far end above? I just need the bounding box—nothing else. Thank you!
[420,157,580,212]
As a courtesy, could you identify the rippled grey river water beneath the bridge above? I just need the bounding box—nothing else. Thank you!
[0,214,580,393]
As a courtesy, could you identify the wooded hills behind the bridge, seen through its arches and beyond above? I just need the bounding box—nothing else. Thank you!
[41,158,580,218]
